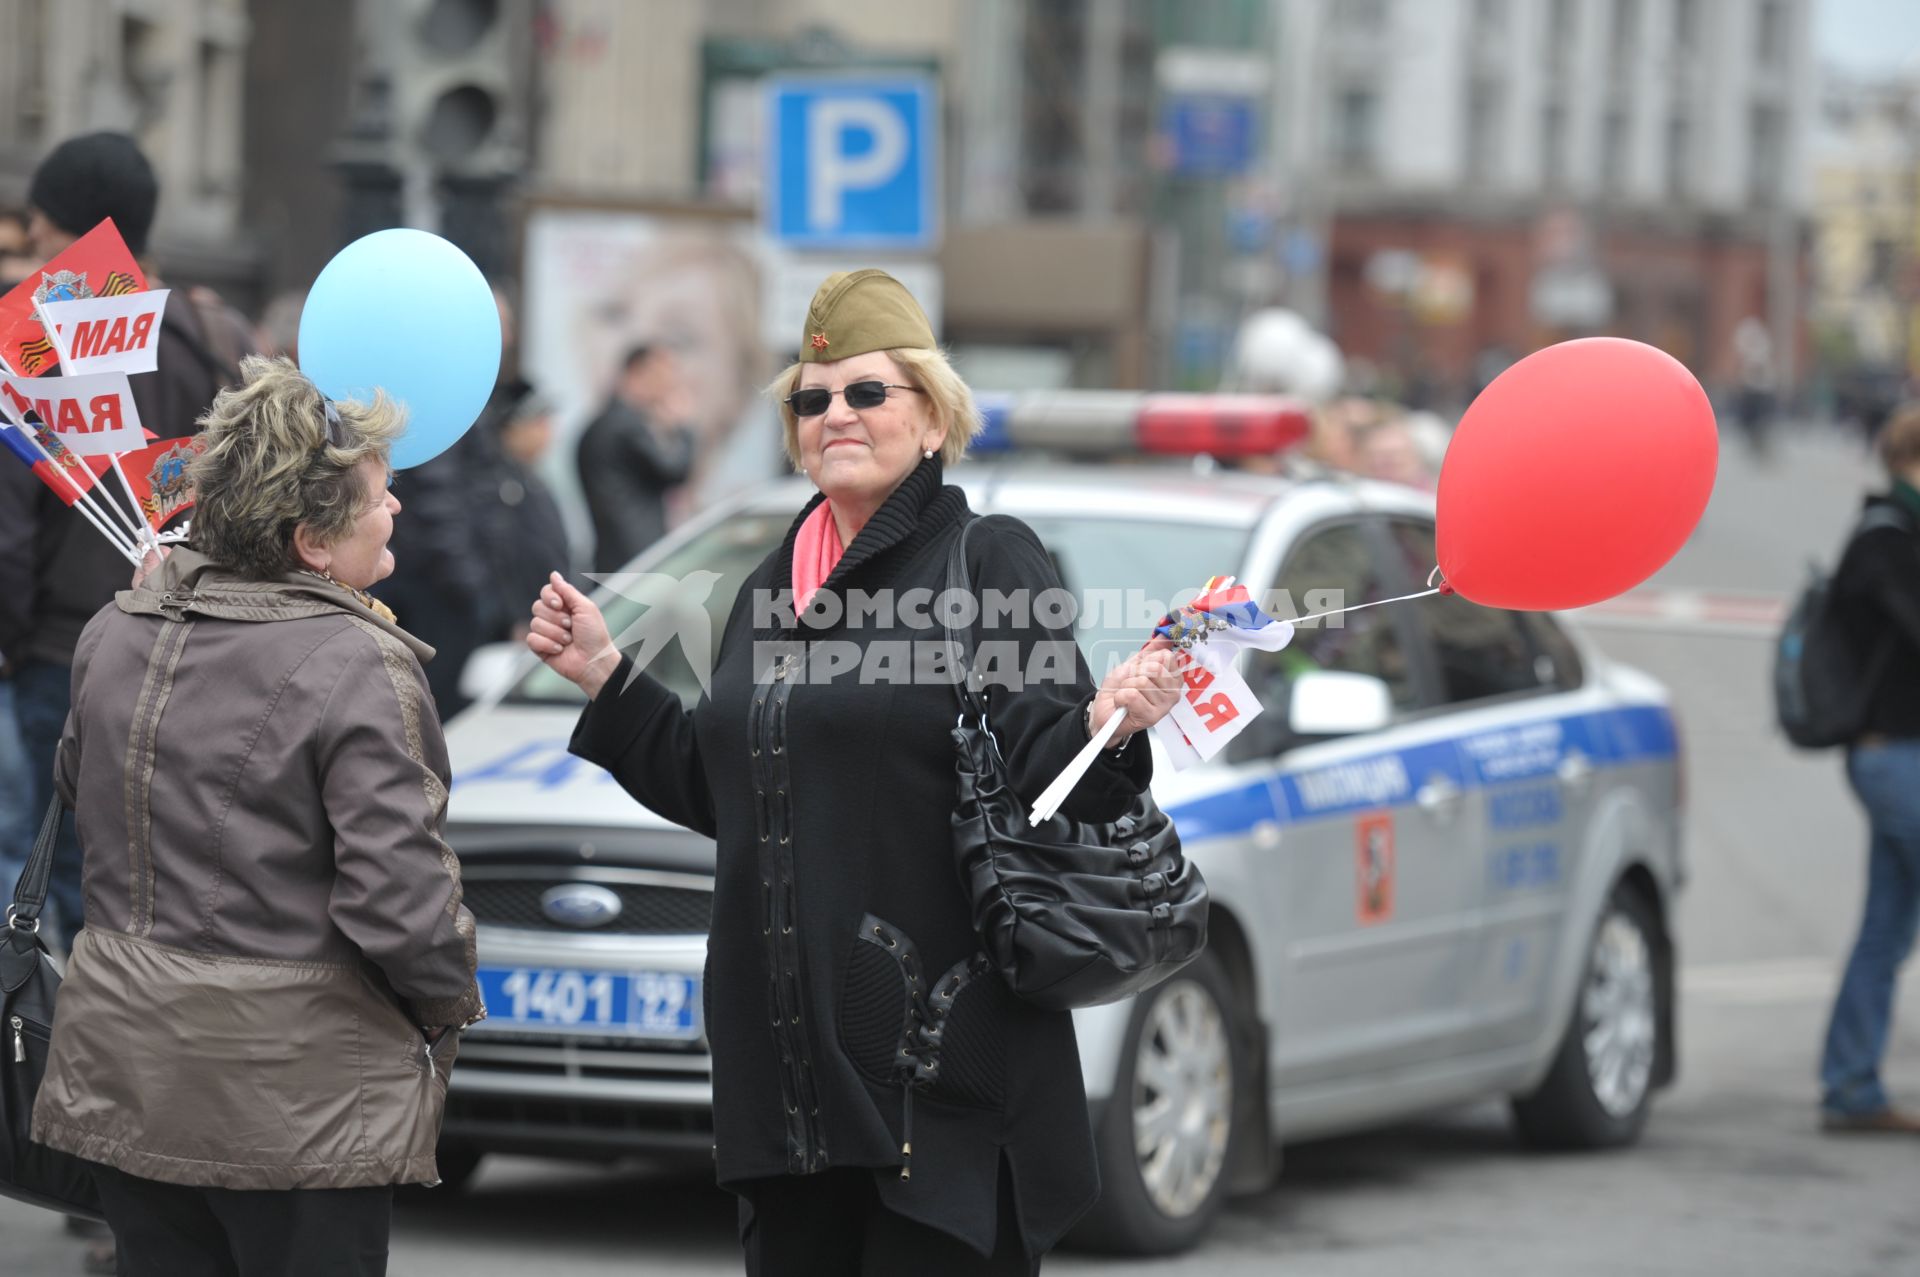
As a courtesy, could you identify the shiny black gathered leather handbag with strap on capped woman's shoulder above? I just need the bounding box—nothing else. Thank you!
[947,522,1208,1010]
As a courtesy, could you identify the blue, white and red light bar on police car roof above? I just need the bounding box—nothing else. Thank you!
[972,390,1309,466]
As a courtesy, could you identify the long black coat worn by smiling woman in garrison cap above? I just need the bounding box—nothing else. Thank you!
[572,459,1152,1254]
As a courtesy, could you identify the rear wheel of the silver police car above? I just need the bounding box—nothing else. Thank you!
[1513,883,1667,1148]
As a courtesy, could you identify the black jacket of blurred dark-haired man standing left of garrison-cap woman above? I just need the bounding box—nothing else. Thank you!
[576,398,693,572]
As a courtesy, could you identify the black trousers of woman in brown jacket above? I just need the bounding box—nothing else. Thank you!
[94,1164,394,1277]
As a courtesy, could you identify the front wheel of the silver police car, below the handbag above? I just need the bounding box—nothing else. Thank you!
[1071,952,1248,1254]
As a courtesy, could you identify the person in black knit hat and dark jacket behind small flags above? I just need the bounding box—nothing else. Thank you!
[0,133,236,941]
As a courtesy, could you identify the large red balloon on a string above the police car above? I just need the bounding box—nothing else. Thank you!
[1436,336,1720,611]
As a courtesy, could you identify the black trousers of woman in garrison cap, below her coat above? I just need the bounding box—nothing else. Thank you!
[741,1166,1041,1277]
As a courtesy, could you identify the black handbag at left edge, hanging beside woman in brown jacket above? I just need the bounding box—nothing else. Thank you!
[0,799,106,1219]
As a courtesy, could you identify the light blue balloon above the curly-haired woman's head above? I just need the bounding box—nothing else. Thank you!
[300,230,501,470]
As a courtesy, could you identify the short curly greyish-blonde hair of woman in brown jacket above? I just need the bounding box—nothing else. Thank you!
[188,355,405,580]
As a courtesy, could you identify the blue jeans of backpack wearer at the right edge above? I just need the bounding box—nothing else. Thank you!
[1820,739,1920,1114]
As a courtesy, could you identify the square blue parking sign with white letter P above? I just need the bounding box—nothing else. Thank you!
[766,75,939,250]
